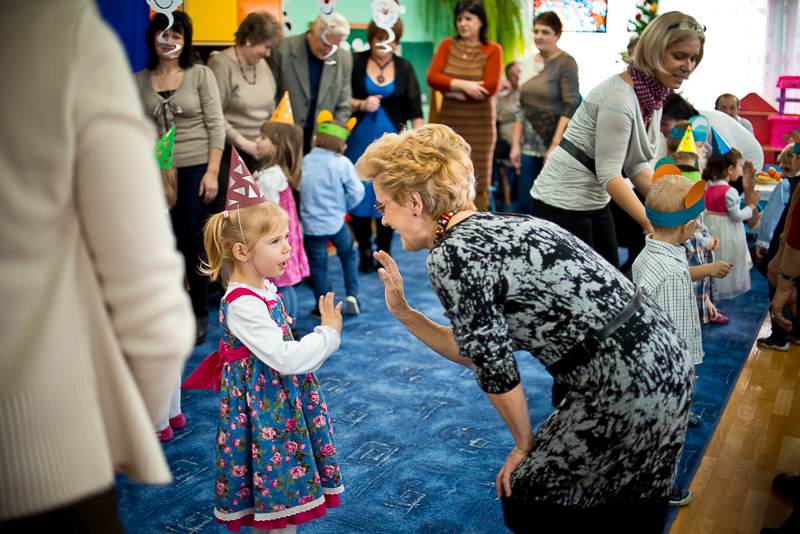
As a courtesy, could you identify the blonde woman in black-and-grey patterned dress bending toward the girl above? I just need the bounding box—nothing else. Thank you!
[357,125,692,533]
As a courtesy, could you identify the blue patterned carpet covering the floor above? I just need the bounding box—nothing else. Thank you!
[117,243,767,534]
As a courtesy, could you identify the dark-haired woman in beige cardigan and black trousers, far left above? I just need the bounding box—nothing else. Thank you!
[136,11,225,352]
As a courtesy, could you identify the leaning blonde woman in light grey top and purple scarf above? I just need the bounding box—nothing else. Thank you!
[531,11,705,267]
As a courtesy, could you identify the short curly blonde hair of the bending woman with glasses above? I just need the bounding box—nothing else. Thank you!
[356,124,475,219]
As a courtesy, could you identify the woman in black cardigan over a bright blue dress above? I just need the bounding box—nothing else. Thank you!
[344,19,423,272]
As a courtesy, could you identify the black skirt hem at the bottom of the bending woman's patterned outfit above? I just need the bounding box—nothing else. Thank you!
[503,495,669,534]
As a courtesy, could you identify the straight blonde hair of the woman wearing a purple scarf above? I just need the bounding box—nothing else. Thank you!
[633,11,706,76]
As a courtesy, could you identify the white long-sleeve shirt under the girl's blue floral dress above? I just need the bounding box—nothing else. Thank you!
[226,281,341,375]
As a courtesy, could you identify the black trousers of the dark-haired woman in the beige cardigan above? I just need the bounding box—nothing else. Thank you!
[170,164,208,319]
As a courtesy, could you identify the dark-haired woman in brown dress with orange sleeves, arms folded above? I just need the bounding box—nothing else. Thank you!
[428,0,503,214]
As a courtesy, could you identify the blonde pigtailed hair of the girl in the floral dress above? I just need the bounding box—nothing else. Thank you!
[200,201,289,283]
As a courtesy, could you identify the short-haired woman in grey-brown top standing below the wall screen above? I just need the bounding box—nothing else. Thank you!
[509,11,581,214]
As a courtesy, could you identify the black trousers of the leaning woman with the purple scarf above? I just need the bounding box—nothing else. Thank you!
[532,198,619,269]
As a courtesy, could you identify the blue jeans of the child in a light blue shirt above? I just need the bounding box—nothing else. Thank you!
[303,224,358,299]
